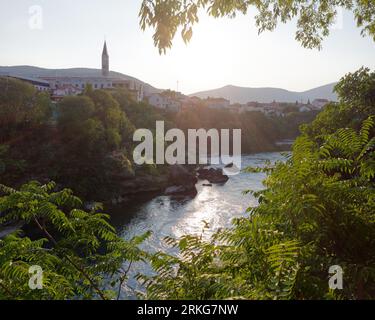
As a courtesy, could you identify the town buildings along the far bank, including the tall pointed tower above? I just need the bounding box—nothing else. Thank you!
[0,42,330,117]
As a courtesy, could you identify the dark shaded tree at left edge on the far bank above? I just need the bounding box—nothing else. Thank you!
[0,77,53,185]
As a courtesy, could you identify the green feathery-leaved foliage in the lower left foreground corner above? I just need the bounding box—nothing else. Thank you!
[0,182,149,300]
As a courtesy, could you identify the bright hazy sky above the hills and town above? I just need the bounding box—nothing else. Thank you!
[0,0,375,94]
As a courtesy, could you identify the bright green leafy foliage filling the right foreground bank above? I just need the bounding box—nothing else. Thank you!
[139,69,375,299]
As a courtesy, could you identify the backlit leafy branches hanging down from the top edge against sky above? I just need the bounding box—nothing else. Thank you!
[139,0,375,53]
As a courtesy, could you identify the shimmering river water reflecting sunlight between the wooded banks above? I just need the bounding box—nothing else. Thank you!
[111,152,284,298]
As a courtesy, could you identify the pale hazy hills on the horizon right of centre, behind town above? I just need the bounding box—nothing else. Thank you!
[190,83,337,103]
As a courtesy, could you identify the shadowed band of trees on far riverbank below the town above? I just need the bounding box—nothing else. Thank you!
[0,78,302,201]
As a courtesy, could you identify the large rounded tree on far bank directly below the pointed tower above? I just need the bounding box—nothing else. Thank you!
[52,90,141,201]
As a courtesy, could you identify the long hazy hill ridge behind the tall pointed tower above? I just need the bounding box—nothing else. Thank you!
[0,66,160,92]
